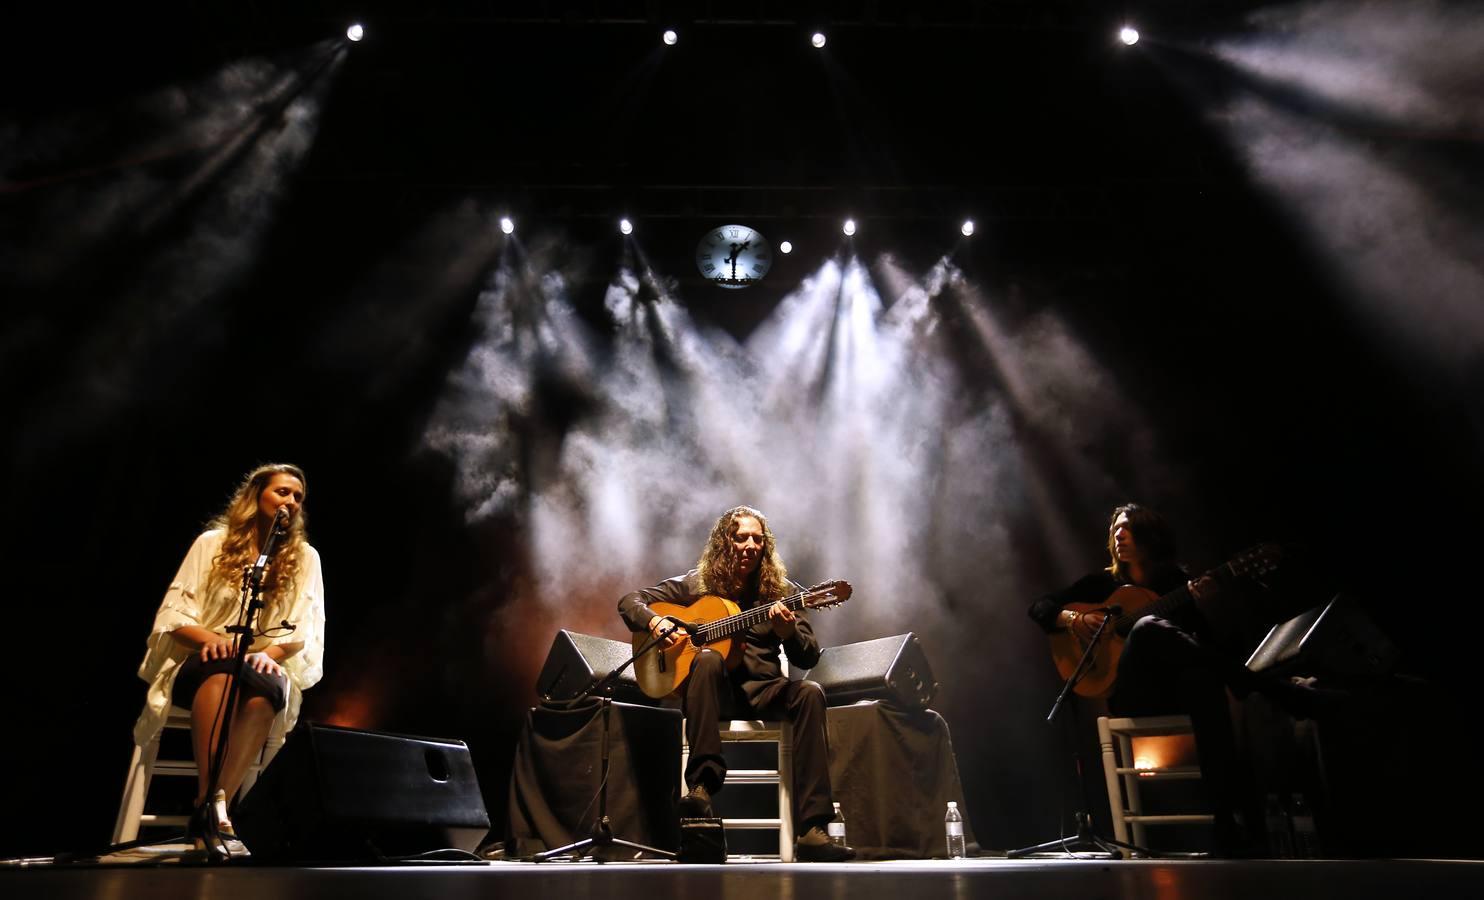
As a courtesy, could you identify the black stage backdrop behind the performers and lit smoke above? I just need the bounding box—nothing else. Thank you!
[0,1,1484,855]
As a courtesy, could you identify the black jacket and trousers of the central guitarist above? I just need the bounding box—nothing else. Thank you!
[619,569,834,833]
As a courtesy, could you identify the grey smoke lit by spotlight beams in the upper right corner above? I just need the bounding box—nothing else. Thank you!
[1215,1,1484,373]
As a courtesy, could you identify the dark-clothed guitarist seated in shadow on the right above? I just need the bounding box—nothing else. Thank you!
[1030,503,1334,852]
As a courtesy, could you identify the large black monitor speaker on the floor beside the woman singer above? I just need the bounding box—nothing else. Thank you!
[233,722,490,861]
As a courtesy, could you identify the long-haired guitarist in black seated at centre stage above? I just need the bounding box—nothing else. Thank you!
[619,506,855,863]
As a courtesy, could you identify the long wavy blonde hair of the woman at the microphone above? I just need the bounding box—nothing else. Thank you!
[206,462,309,628]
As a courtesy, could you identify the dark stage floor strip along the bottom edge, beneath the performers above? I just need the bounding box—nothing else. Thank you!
[0,858,1484,900]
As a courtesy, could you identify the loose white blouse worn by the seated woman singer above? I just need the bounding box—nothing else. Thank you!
[134,529,325,746]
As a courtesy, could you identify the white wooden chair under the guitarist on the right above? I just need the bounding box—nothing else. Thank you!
[1098,716,1215,847]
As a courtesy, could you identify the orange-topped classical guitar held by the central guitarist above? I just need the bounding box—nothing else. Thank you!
[634,581,852,698]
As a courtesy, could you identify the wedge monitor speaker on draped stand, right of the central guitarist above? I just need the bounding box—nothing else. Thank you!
[804,631,938,710]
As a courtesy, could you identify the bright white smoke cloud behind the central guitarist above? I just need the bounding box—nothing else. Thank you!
[426,243,1181,680]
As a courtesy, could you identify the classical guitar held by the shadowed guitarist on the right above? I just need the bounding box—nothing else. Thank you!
[1051,544,1282,697]
